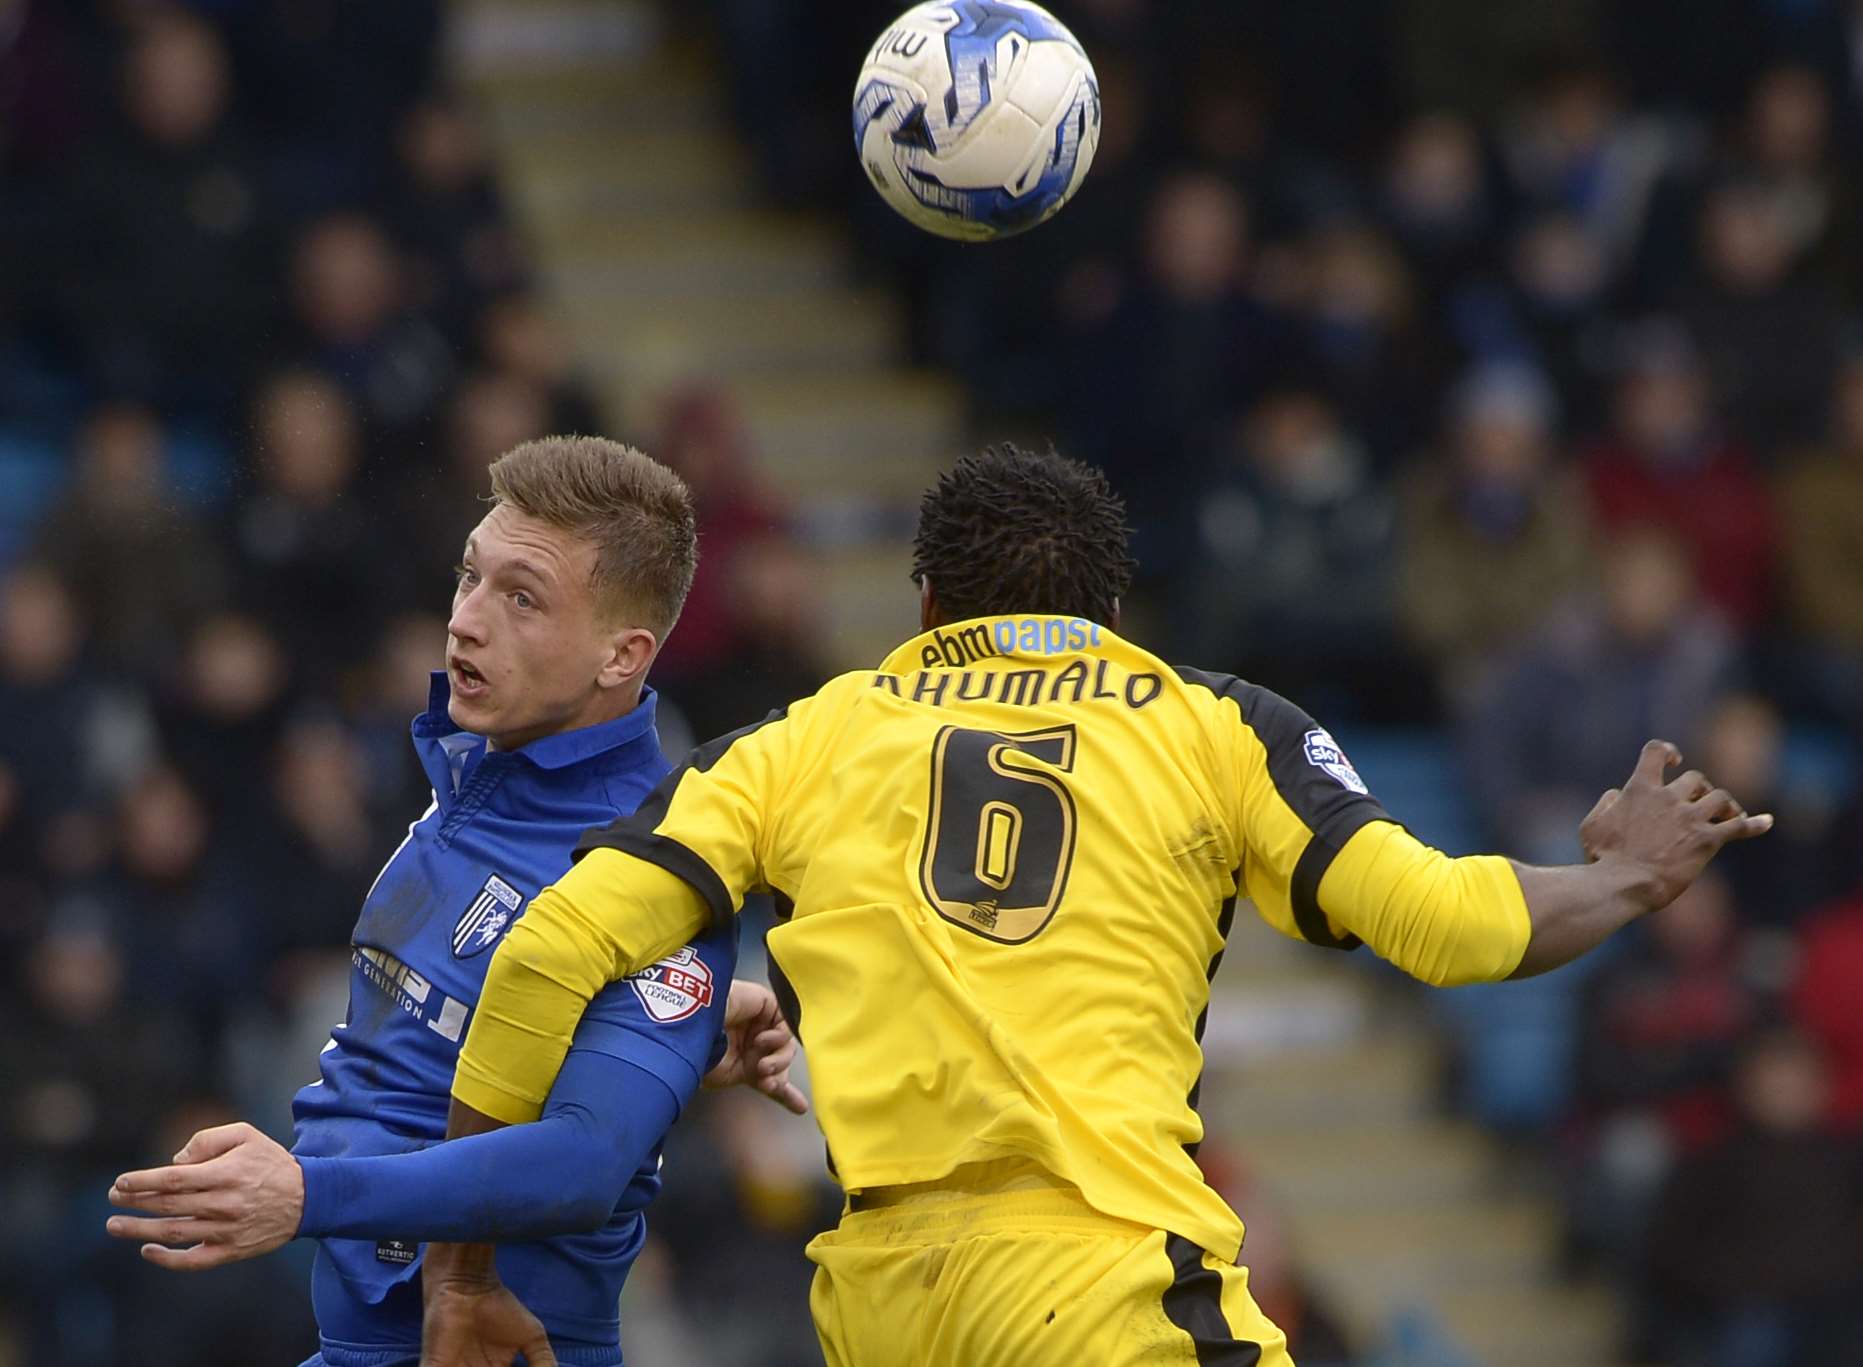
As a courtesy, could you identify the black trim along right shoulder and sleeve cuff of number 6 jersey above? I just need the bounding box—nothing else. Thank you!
[1177,667,1392,950]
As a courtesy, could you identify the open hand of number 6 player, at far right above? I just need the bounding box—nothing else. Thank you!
[1578,741,1772,911]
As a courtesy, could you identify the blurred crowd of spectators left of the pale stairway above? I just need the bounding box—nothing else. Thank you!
[0,0,825,1367]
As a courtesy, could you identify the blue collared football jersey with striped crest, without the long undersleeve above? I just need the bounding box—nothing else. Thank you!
[292,674,738,1347]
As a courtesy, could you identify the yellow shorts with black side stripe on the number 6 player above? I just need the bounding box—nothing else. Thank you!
[809,1164,1293,1367]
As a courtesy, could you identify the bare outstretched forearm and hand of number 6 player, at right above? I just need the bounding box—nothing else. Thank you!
[1511,741,1772,978]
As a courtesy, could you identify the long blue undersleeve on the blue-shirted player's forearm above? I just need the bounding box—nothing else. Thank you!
[298,1041,689,1244]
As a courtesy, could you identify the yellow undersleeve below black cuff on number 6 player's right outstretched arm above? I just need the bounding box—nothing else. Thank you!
[1319,821,1533,987]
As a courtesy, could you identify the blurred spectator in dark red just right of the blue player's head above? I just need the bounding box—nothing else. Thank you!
[650,389,782,689]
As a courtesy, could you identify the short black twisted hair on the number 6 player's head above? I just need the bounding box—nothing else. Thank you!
[913,441,1136,624]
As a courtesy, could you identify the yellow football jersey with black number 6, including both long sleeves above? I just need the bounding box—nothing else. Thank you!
[455,616,1528,1259]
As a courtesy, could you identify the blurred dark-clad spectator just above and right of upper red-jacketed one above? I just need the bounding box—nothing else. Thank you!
[1680,181,1839,454]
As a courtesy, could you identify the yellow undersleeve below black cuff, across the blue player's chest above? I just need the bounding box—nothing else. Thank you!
[453,849,710,1125]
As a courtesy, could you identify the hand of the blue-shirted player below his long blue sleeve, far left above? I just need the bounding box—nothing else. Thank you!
[104,1123,304,1272]
